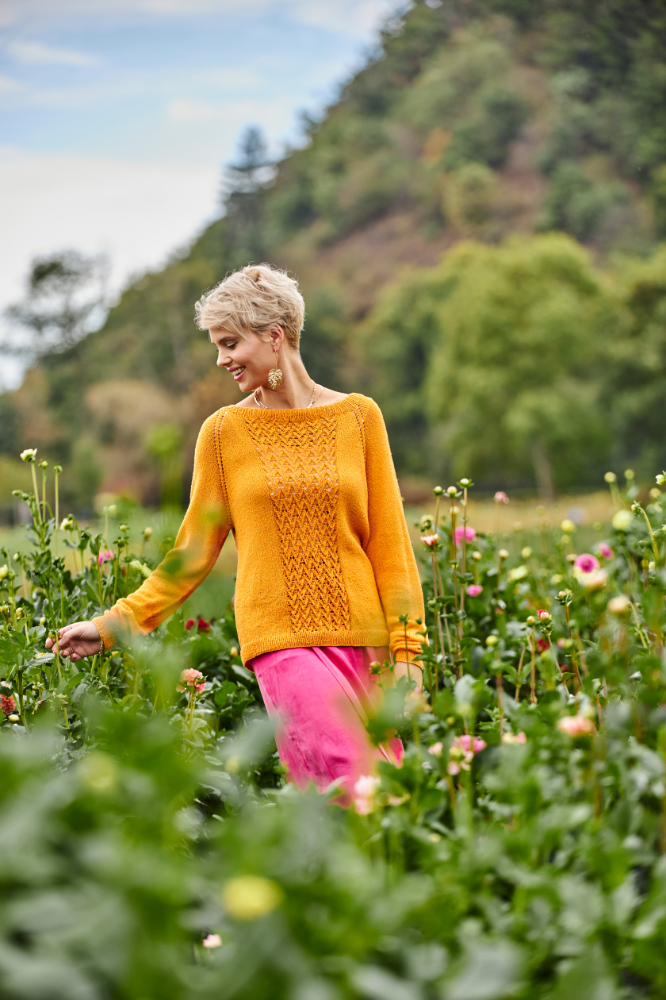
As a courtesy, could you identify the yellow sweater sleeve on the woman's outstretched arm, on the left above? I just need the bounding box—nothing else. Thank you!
[93,414,231,649]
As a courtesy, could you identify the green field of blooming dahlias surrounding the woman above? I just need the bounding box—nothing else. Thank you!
[0,452,666,1000]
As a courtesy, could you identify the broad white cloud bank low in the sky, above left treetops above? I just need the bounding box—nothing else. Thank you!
[0,147,219,381]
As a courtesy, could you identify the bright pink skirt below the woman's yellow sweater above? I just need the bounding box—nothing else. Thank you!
[247,646,403,802]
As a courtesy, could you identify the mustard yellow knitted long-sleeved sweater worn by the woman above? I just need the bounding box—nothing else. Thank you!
[94,393,423,662]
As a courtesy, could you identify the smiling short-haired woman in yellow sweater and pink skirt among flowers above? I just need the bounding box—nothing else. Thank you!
[46,264,423,790]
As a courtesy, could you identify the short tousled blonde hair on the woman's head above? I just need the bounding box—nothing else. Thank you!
[194,264,305,348]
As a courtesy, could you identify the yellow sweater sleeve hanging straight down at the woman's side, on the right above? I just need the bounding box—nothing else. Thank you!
[364,400,425,661]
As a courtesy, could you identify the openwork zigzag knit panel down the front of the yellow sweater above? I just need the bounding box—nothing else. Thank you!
[246,414,350,632]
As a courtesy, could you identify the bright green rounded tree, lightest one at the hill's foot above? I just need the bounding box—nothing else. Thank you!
[426,235,612,499]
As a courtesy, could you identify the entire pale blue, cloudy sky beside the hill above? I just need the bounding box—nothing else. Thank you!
[0,0,399,387]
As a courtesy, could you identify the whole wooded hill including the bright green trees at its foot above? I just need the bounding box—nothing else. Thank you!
[0,0,666,505]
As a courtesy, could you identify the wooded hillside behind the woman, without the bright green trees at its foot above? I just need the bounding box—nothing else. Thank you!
[0,0,666,505]
